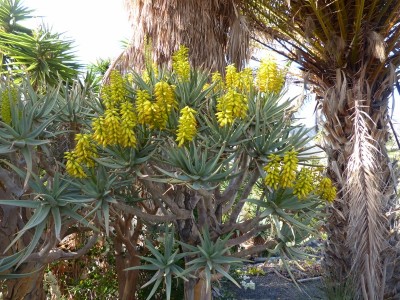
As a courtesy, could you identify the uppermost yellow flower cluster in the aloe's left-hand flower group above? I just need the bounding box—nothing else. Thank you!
[101,70,128,108]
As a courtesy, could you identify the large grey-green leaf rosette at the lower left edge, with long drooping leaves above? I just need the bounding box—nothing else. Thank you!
[0,169,95,276]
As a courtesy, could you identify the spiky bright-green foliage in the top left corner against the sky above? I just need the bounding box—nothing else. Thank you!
[0,0,81,89]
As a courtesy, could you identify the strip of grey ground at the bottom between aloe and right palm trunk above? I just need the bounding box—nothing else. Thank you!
[214,245,328,300]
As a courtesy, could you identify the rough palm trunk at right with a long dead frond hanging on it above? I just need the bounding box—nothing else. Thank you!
[322,78,400,299]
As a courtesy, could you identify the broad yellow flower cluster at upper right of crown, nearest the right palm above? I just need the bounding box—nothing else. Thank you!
[256,57,285,93]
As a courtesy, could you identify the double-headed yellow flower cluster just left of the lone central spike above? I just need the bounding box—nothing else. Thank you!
[136,81,178,129]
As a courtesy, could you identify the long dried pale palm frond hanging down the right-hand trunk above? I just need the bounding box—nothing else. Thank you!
[346,100,388,299]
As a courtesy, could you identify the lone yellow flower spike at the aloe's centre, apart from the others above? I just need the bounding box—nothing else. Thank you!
[176,106,197,147]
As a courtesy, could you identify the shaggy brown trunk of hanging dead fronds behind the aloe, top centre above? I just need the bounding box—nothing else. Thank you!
[112,0,249,72]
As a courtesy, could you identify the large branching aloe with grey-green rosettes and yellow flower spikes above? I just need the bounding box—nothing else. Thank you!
[0,48,335,299]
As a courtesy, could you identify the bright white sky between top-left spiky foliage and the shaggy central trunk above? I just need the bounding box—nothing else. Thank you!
[23,0,131,64]
